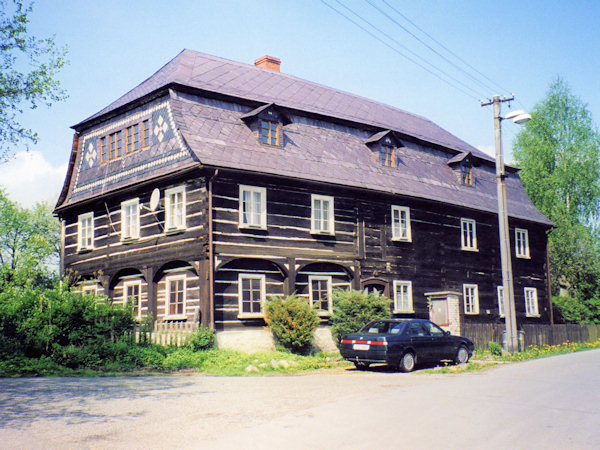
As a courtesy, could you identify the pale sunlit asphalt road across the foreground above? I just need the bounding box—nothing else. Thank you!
[0,350,600,449]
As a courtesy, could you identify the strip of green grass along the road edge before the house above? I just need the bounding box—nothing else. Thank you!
[0,339,600,377]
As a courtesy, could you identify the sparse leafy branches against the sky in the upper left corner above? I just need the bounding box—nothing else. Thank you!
[0,0,67,163]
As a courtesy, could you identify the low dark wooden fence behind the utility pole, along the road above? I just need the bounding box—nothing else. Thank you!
[462,323,600,348]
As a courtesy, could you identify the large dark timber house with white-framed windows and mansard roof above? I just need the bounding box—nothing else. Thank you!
[56,50,552,342]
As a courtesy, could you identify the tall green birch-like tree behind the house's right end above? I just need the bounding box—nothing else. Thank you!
[513,78,600,322]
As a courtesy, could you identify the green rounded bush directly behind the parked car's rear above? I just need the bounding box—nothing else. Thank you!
[329,289,391,344]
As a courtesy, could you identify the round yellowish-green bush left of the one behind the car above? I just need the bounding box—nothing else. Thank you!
[265,295,319,354]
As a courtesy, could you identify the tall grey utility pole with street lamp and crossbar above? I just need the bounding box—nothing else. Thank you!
[481,95,531,353]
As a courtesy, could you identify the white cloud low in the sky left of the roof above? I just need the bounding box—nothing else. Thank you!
[0,151,67,208]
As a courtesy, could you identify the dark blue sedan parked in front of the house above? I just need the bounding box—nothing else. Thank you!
[340,319,475,372]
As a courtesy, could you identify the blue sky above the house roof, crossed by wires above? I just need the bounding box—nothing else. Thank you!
[0,0,600,205]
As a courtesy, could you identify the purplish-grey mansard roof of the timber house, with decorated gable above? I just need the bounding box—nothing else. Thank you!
[57,50,551,225]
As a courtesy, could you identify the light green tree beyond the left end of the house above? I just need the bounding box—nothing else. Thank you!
[0,189,60,286]
